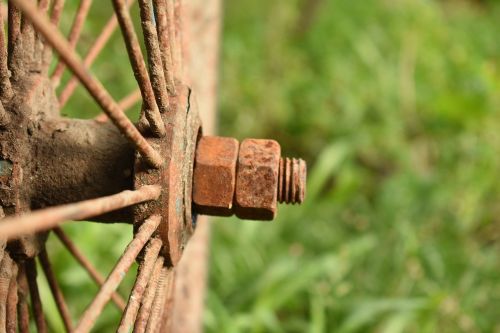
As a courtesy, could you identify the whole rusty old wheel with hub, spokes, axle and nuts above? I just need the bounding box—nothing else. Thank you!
[0,0,305,332]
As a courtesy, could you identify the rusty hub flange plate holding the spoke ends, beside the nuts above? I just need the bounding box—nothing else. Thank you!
[134,86,201,265]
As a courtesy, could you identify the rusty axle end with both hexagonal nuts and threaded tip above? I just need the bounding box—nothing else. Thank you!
[193,137,307,220]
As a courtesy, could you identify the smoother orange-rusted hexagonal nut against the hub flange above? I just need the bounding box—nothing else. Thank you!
[193,136,239,216]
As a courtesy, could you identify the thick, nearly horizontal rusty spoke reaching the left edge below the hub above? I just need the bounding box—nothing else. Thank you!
[0,185,161,239]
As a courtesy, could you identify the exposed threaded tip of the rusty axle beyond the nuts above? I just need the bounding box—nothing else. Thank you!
[278,157,307,204]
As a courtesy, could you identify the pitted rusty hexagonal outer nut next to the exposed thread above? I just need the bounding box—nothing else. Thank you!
[234,139,281,220]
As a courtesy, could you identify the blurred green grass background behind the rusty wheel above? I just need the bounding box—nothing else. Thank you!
[40,0,500,333]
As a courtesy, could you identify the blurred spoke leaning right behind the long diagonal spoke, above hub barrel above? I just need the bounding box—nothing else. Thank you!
[59,0,133,108]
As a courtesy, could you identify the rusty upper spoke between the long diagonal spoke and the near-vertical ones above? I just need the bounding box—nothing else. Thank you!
[113,0,166,136]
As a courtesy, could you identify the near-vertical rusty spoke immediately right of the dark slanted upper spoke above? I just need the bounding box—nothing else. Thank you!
[139,0,169,113]
